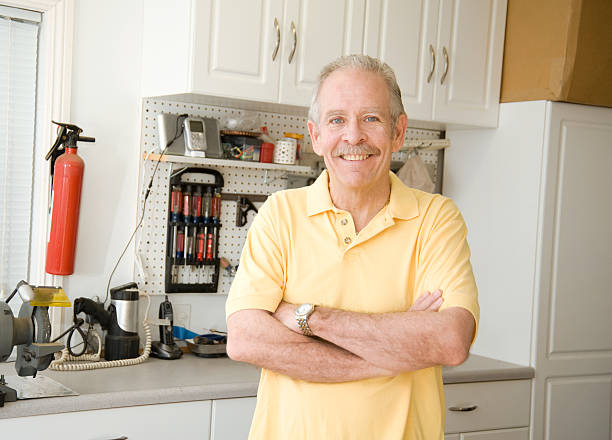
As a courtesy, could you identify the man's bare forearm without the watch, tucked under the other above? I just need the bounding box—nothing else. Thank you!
[227,310,392,382]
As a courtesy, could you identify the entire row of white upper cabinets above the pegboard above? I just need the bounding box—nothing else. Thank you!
[142,0,507,127]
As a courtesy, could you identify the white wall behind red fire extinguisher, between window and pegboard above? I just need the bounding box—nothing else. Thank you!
[64,0,143,298]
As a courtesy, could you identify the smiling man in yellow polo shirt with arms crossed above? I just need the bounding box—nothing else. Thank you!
[226,55,479,440]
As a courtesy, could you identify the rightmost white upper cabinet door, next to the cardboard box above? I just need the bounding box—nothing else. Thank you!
[434,0,507,127]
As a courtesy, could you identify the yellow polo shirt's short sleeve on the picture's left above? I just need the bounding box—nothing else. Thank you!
[225,196,286,318]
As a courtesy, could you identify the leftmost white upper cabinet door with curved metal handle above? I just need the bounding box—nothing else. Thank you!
[188,0,283,102]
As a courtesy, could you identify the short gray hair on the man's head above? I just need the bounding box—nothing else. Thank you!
[308,55,406,128]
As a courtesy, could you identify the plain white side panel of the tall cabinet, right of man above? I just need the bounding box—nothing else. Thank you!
[444,101,545,365]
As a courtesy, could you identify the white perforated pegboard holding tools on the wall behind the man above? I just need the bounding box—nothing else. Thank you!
[135,98,440,295]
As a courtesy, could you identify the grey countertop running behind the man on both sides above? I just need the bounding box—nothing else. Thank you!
[0,353,534,419]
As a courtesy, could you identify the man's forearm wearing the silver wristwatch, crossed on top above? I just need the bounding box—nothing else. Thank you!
[309,307,473,373]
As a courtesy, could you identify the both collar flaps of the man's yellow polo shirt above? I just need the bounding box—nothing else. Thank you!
[307,170,419,220]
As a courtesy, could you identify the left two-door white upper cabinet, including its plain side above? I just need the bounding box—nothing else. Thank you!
[142,0,364,106]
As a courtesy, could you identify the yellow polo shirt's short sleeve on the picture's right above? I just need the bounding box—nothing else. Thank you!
[416,198,480,342]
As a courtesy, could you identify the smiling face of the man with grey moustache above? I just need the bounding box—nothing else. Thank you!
[308,68,407,196]
